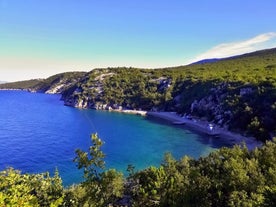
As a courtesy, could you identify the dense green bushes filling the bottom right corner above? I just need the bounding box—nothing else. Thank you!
[132,141,276,206]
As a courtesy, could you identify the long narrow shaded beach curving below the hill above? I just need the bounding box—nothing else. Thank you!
[146,112,262,150]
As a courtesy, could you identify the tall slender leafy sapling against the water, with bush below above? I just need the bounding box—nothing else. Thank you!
[73,134,123,206]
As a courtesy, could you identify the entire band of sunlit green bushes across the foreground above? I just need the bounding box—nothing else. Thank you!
[0,134,276,207]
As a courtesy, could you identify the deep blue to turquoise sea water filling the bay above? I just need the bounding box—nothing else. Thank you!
[0,91,232,186]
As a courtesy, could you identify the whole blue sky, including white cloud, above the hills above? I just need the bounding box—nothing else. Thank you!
[0,0,276,81]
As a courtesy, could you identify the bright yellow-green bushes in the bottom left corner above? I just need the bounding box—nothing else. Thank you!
[0,169,63,207]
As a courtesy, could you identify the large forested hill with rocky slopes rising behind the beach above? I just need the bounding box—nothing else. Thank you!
[1,48,276,139]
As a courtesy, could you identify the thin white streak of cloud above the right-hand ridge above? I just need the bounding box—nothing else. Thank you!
[189,32,276,63]
